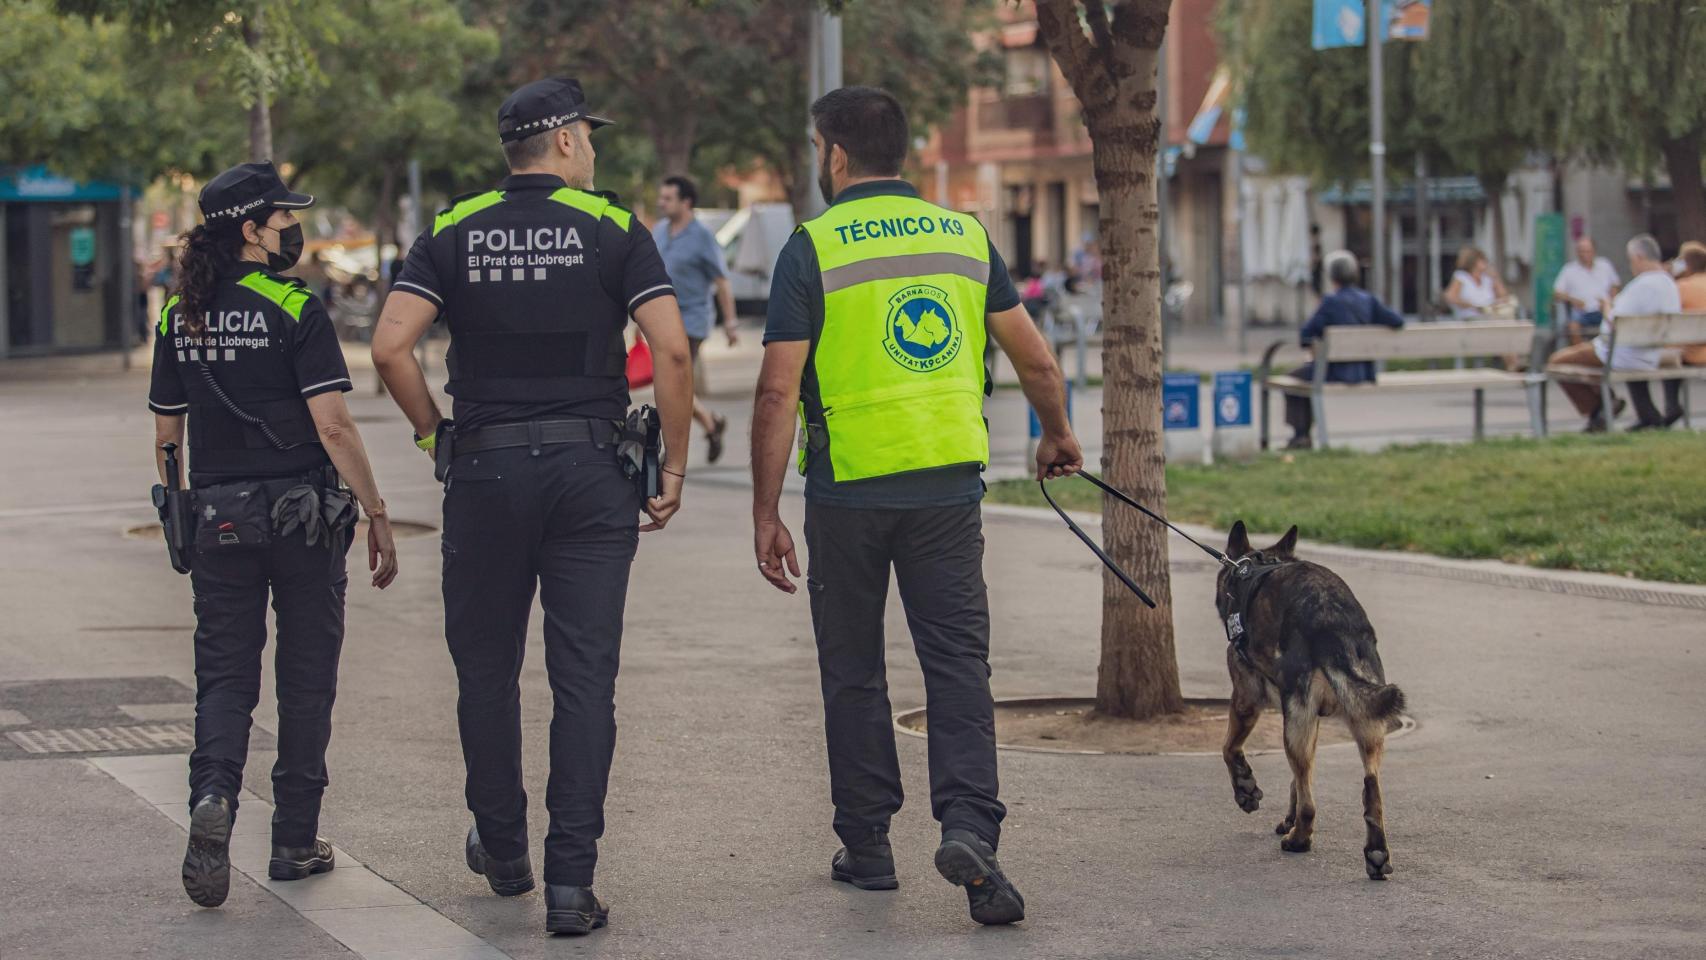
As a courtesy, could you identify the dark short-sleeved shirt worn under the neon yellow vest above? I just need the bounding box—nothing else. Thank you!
[764,181,1018,510]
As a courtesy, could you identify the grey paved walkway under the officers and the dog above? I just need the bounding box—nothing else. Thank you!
[0,327,1706,960]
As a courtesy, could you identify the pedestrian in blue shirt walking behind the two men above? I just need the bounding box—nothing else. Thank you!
[652,177,740,464]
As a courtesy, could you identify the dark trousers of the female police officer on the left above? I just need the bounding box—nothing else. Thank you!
[189,491,353,846]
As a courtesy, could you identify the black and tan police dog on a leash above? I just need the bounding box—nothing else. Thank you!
[1218,520,1404,880]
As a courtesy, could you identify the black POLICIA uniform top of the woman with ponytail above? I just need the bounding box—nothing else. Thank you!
[148,263,351,486]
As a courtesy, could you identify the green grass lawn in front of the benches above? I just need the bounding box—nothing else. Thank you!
[989,431,1706,583]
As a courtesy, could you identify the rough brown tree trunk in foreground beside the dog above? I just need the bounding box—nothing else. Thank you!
[1037,0,1184,720]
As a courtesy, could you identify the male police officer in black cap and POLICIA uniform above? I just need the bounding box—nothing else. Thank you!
[374,78,693,933]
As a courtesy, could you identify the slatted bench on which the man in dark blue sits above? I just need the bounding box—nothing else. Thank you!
[1257,321,1544,450]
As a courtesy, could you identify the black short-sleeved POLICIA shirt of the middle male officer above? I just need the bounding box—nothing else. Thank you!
[392,174,676,431]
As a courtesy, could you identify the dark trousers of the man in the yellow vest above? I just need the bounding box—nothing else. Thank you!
[805,501,1007,846]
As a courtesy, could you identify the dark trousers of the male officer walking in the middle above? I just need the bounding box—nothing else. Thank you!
[444,443,640,887]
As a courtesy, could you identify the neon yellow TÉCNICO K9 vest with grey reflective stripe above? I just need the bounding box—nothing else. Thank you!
[800,196,989,483]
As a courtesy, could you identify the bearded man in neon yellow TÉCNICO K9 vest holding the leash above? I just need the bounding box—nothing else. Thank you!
[752,87,1083,924]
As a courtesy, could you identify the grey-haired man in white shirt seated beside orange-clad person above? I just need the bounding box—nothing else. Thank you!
[1547,234,1682,433]
